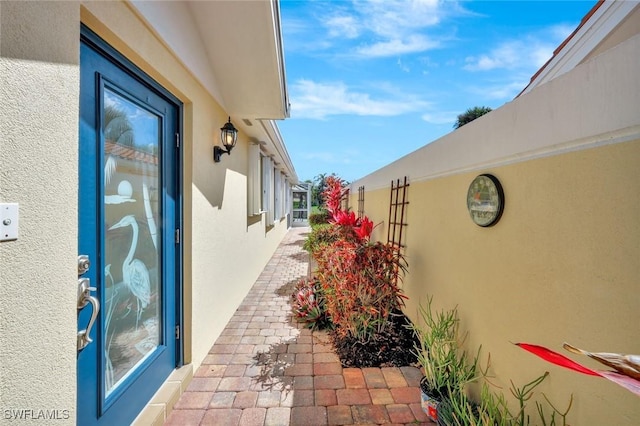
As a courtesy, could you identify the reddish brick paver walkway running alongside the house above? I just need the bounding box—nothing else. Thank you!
[165,228,433,426]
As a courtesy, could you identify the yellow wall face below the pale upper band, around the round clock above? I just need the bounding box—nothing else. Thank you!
[365,140,640,425]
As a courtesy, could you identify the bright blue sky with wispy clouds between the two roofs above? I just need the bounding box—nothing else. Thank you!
[278,0,595,181]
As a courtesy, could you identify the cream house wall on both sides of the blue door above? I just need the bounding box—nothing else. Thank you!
[0,1,287,424]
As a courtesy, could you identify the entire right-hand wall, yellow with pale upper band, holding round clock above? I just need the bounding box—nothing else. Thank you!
[351,32,640,425]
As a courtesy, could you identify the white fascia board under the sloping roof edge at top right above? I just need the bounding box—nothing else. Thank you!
[520,1,638,95]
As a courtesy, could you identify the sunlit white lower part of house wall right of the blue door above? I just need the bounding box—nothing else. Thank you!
[192,171,287,367]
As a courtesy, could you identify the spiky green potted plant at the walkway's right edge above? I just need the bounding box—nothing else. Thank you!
[413,297,479,421]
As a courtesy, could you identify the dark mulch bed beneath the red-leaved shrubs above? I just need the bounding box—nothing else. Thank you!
[332,312,417,368]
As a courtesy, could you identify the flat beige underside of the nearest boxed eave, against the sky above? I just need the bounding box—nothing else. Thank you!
[188,0,288,119]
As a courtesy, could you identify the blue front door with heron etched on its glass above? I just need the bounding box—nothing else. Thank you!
[77,27,181,425]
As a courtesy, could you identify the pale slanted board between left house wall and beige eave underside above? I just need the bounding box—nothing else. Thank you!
[130,0,226,109]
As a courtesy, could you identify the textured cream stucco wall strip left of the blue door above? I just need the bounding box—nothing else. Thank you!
[0,1,80,425]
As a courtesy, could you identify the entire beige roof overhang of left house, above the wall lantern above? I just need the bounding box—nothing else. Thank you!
[130,0,297,181]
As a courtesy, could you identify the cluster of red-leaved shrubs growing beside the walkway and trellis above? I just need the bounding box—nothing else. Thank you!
[294,176,407,343]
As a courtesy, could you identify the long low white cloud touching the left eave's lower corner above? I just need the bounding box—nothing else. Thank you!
[291,80,427,119]
